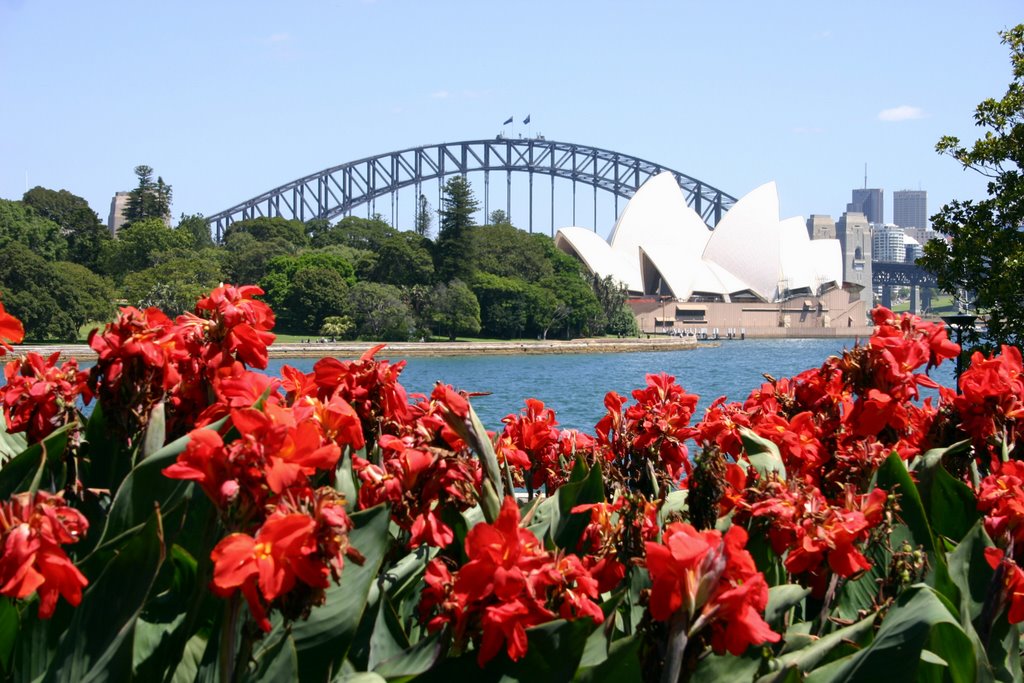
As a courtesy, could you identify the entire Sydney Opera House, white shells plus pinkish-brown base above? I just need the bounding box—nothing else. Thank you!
[555,173,866,336]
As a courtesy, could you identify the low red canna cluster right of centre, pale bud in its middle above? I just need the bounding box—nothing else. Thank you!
[645,522,780,655]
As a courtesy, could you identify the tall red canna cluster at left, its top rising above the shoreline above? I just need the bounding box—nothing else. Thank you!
[89,285,273,434]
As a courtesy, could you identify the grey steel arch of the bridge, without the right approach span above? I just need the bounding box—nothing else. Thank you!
[206,137,736,242]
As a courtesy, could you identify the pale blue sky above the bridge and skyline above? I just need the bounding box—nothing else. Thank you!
[0,0,1024,230]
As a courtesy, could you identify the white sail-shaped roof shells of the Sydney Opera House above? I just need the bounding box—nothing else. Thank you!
[555,172,843,301]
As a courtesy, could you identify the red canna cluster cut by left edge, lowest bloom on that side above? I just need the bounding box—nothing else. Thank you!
[0,492,89,618]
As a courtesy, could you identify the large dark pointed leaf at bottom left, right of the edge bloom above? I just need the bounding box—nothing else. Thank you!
[45,507,164,683]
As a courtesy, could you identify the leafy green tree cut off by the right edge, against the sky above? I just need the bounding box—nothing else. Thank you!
[918,25,1024,345]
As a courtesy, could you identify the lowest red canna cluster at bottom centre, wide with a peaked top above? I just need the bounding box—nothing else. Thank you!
[420,498,604,667]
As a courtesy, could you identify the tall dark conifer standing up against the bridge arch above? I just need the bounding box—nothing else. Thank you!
[434,175,479,283]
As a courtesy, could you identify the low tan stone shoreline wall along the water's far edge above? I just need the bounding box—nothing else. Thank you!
[9,328,871,360]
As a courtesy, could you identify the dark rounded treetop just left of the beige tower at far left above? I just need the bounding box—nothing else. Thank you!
[22,185,111,270]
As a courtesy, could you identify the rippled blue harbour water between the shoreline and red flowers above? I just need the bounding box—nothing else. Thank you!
[267,339,953,432]
